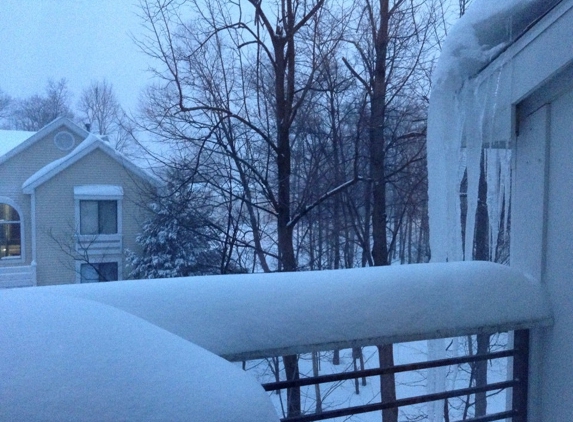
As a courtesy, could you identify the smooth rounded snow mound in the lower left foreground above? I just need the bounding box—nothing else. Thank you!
[0,288,278,422]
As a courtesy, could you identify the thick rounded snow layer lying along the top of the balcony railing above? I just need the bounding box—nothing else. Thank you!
[27,262,551,360]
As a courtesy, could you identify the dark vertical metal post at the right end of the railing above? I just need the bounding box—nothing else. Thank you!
[513,330,529,422]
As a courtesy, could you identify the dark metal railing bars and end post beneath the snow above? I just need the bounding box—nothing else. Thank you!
[263,330,529,422]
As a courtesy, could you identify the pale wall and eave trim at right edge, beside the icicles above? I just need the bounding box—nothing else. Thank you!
[454,0,573,422]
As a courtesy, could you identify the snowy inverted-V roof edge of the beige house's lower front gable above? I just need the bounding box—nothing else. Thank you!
[22,133,160,194]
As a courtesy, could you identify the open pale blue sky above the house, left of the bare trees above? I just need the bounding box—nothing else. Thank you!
[0,0,149,112]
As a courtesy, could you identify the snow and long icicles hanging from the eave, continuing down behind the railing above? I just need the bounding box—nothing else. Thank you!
[422,0,543,422]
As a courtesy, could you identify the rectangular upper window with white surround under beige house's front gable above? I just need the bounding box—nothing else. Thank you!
[80,200,118,234]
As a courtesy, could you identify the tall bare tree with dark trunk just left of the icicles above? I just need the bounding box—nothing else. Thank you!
[345,0,437,422]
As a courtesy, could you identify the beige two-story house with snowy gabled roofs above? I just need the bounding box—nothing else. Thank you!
[0,118,157,287]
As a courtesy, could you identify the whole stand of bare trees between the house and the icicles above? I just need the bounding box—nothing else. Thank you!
[128,0,450,422]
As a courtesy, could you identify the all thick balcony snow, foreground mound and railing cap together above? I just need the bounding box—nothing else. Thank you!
[0,262,552,421]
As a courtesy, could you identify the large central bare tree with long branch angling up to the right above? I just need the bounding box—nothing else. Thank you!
[133,0,370,416]
